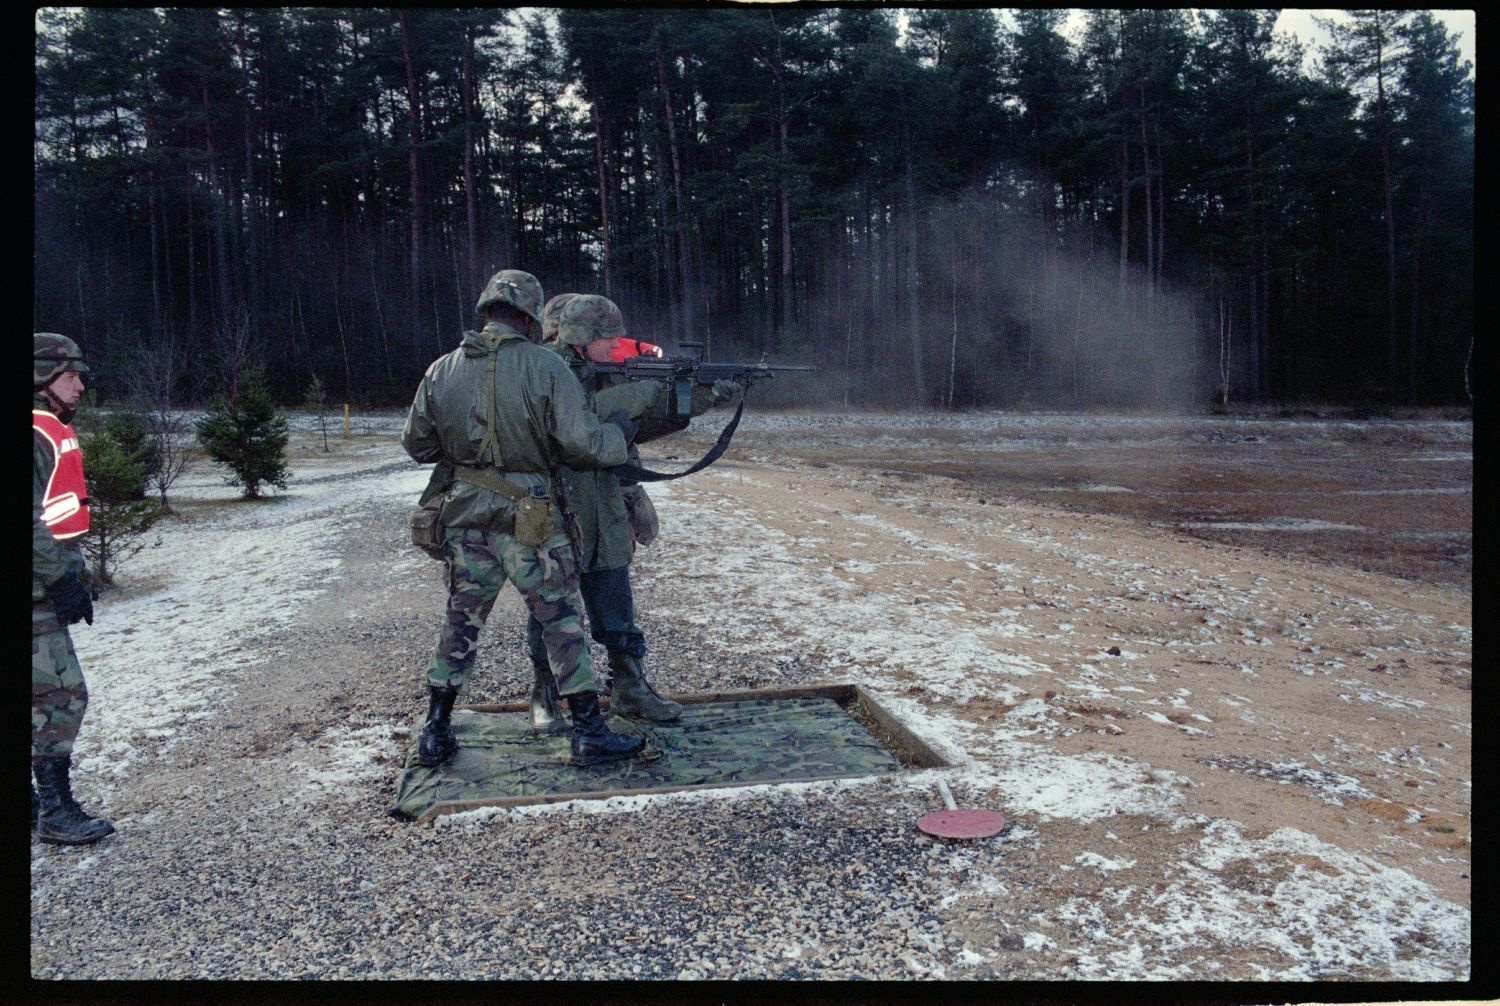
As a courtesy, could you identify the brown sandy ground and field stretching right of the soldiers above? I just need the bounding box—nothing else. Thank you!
[641,420,1473,906]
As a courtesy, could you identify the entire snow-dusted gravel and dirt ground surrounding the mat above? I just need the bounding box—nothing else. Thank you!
[32,409,1473,983]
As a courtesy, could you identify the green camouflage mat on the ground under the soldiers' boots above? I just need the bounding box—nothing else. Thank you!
[392,696,902,817]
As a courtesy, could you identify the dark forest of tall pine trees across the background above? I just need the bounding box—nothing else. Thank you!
[33,4,1475,411]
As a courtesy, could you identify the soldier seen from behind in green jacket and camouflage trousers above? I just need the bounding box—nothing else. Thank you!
[401,270,644,766]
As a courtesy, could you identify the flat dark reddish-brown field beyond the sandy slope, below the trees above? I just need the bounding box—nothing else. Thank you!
[708,417,1475,589]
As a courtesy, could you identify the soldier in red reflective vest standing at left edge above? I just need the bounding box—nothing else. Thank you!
[32,331,114,846]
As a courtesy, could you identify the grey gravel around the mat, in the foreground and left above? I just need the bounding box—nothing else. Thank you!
[32,428,1028,979]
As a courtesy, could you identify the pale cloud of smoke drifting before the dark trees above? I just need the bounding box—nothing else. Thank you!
[777,191,1212,412]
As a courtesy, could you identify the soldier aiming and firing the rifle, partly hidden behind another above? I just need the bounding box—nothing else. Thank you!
[527,294,741,730]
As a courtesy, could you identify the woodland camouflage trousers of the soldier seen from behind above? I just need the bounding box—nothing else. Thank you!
[428,528,599,696]
